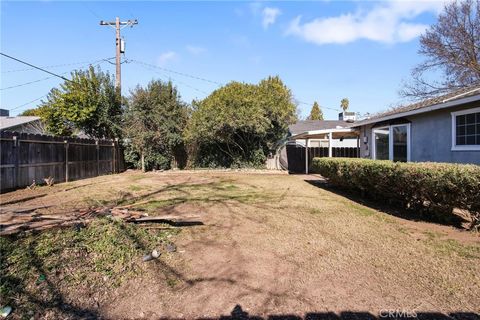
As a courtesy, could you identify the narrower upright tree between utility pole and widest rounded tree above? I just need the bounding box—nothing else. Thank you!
[124,80,188,171]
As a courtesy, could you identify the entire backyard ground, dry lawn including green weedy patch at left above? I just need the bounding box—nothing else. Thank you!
[0,171,480,319]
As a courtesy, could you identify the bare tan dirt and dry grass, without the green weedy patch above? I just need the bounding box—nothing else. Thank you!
[2,172,480,319]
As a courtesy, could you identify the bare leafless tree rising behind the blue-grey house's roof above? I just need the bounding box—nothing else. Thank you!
[400,0,480,98]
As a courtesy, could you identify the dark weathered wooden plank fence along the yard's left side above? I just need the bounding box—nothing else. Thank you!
[0,132,125,192]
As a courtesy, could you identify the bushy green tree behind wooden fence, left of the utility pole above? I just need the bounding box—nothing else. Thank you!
[38,66,122,138]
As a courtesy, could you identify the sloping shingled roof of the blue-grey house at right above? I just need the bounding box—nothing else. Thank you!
[352,84,480,127]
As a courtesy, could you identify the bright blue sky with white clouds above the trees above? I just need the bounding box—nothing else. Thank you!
[0,1,442,119]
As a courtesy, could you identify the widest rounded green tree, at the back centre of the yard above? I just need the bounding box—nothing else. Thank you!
[185,77,296,167]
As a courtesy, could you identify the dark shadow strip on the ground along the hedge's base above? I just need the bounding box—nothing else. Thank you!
[305,178,470,230]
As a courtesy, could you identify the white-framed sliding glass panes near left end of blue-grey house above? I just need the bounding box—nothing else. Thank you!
[373,123,410,162]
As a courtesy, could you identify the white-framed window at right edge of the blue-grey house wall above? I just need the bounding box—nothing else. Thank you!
[452,108,480,151]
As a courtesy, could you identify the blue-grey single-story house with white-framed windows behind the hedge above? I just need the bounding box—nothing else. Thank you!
[351,85,480,164]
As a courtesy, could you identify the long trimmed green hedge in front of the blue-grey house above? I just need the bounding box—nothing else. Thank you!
[312,158,480,228]
